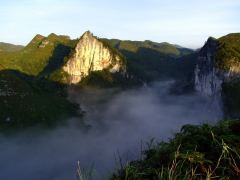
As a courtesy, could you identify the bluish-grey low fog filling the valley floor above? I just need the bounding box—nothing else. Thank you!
[0,81,221,180]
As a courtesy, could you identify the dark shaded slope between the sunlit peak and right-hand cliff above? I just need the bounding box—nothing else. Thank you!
[120,48,197,90]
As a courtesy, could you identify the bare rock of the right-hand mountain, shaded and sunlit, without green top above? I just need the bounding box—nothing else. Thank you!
[195,38,240,96]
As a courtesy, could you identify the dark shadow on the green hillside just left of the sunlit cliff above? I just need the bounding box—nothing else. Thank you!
[38,44,71,78]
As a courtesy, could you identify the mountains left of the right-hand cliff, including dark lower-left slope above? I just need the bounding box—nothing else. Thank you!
[0,31,193,127]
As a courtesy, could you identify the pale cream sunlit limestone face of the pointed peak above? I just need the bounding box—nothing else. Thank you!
[63,31,126,84]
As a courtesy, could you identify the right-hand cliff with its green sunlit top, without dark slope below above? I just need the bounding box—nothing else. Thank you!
[195,34,240,96]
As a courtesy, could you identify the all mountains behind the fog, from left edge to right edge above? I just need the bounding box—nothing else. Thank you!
[0,31,240,127]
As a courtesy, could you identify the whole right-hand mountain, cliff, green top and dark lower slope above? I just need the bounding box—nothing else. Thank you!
[195,33,240,117]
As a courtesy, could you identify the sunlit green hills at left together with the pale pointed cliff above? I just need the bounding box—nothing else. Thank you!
[0,31,129,84]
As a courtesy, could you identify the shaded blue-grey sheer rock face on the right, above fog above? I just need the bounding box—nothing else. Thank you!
[195,38,224,119]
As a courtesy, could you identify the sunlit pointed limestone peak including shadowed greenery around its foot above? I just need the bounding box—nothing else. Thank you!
[50,31,126,86]
